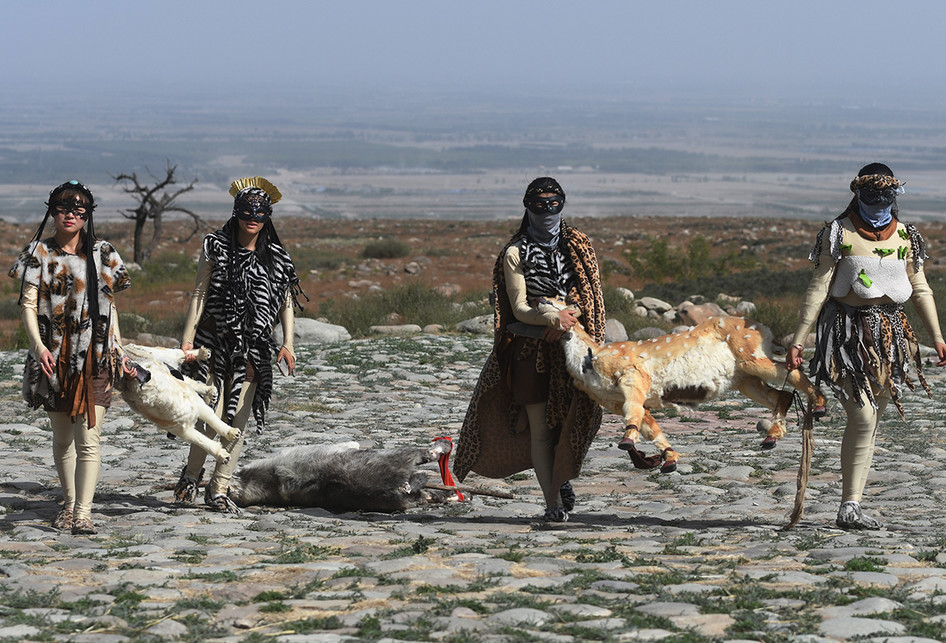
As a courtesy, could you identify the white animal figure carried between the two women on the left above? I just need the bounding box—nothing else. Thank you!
[115,344,240,462]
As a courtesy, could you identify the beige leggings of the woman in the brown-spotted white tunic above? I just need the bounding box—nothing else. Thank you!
[47,406,105,518]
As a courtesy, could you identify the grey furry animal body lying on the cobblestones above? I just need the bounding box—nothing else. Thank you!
[229,440,456,513]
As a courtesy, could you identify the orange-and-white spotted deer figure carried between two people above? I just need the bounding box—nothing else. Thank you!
[540,299,825,473]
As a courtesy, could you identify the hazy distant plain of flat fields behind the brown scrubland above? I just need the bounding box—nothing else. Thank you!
[0,91,946,221]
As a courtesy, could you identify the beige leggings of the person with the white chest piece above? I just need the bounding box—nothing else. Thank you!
[841,383,890,502]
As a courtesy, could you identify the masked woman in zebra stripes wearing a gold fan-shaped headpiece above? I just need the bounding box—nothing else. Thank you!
[174,176,301,513]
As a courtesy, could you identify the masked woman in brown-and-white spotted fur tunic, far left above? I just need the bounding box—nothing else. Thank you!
[10,181,134,534]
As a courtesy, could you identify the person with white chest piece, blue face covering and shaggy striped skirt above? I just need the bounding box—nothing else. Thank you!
[785,163,946,529]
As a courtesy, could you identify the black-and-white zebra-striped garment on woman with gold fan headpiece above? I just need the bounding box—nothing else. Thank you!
[194,219,299,432]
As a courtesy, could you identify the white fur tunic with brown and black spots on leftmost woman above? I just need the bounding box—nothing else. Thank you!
[9,237,131,409]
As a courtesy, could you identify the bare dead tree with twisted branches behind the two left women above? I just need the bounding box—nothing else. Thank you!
[112,161,205,263]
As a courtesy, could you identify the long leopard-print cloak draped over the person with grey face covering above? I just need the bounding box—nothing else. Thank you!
[454,222,605,487]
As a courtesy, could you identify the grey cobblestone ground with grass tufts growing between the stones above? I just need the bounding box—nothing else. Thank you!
[0,335,946,643]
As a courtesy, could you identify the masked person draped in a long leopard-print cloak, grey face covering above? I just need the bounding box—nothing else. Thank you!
[454,177,605,522]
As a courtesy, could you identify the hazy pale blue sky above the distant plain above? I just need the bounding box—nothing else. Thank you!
[11,0,946,102]
